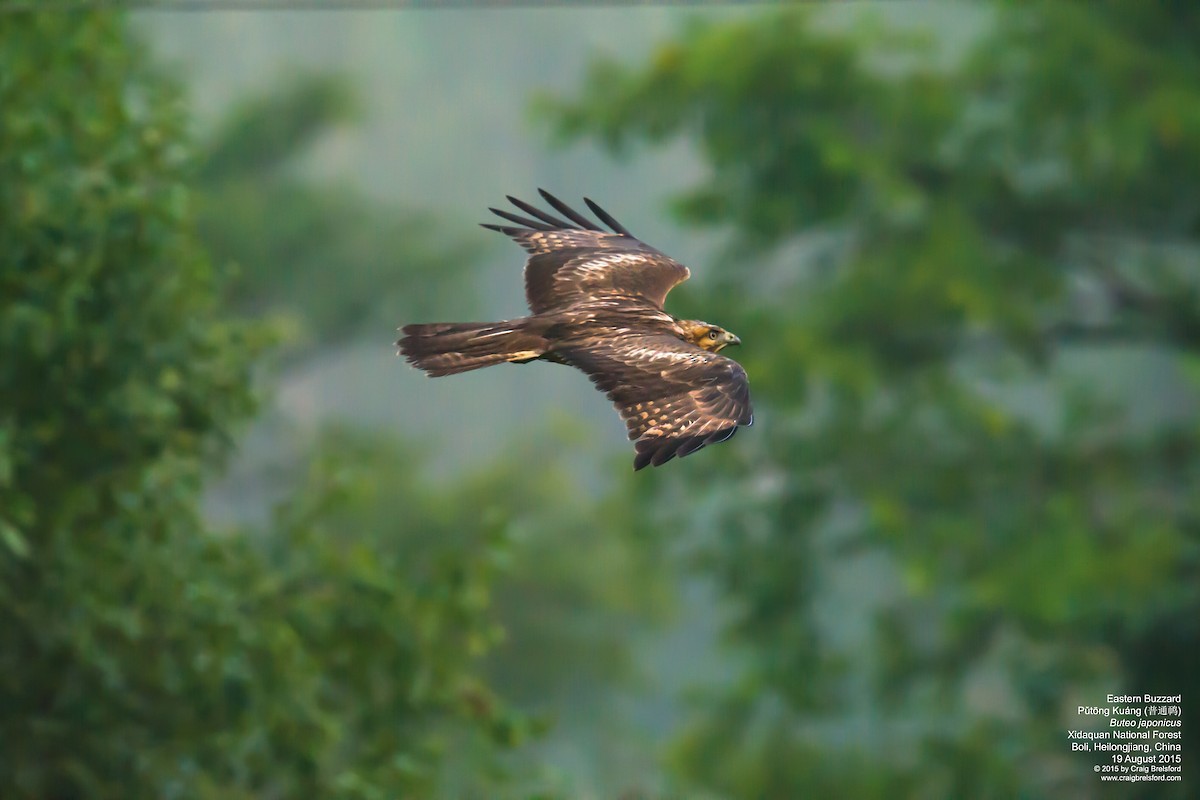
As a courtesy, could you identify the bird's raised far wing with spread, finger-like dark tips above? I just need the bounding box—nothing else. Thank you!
[484,190,689,314]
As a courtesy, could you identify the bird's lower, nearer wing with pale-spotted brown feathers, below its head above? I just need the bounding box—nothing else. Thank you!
[554,332,754,469]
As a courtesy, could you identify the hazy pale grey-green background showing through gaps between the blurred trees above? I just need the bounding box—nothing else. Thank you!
[137,2,1022,796]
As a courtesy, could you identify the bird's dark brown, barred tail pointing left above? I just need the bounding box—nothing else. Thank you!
[396,319,546,378]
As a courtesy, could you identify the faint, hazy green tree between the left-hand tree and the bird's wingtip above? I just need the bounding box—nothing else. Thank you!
[198,76,479,350]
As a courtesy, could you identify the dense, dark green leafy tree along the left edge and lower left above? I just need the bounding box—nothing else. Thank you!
[0,13,526,799]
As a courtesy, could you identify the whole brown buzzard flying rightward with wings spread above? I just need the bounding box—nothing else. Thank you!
[396,190,754,470]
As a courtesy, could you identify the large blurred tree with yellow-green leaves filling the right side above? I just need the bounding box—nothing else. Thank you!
[541,0,1200,798]
